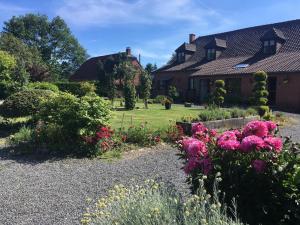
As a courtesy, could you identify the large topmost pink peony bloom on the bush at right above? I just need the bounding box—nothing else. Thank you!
[243,120,269,138]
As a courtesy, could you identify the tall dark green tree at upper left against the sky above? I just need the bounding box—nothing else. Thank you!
[3,14,88,79]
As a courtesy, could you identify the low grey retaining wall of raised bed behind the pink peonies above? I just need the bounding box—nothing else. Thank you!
[176,116,260,135]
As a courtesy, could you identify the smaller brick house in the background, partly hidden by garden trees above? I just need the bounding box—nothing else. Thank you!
[70,47,143,86]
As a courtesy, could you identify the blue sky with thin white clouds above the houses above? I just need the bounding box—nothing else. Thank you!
[0,0,300,66]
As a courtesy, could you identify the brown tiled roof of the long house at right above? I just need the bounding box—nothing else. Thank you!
[158,20,300,76]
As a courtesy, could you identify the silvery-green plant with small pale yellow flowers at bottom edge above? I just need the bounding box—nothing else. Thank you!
[81,180,241,225]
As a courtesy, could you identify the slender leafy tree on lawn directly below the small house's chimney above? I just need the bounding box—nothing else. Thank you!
[121,61,136,110]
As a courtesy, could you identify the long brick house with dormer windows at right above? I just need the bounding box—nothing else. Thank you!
[154,20,300,112]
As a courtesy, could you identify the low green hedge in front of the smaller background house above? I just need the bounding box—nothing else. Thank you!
[54,82,96,97]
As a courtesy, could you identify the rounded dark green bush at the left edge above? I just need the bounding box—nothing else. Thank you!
[0,90,55,118]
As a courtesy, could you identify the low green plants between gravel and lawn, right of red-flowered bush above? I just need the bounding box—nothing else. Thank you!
[120,124,160,146]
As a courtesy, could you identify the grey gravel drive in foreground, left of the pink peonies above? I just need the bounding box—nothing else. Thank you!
[0,146,188,225]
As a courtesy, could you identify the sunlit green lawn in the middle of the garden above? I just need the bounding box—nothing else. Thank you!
[111,103,201,129]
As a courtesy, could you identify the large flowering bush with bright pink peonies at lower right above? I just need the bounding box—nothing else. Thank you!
[178,121,300,225]
